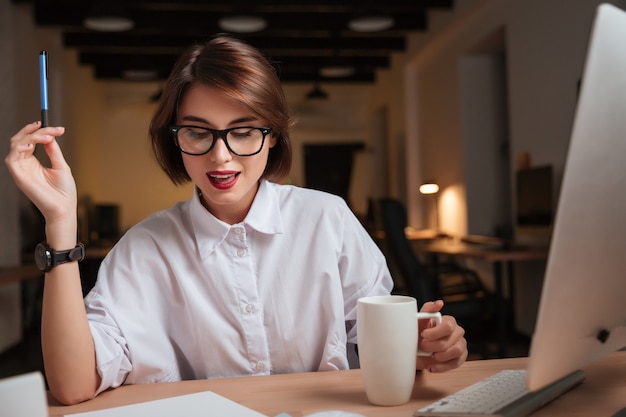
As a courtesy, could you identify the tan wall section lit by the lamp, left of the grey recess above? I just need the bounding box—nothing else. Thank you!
[405,1,504,235]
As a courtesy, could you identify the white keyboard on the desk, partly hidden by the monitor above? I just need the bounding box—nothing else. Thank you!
[413,370,585,417]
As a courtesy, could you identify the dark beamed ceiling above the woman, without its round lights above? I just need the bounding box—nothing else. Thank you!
[11,0,453,83]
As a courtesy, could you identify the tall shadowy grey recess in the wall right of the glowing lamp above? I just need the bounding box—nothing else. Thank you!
[459,50,512,236]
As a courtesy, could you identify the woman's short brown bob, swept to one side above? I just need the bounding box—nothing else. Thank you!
[150,34,292,184]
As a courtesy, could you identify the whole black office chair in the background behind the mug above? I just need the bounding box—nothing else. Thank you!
[378,198,496,357]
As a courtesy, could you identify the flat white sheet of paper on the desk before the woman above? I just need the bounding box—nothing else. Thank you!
[66,391,267,417]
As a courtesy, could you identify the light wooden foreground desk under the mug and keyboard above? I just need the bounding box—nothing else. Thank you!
[48,352,626,417]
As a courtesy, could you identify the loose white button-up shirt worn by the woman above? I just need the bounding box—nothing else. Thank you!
[85,181,392,392]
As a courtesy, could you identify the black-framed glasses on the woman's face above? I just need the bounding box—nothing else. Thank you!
[170,126,272,156]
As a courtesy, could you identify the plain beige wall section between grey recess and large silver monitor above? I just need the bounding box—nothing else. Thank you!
[507,0,612,192]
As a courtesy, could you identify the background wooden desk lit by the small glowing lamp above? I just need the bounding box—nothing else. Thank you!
[414,239,548,357]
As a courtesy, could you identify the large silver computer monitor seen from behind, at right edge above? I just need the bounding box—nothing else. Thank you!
[527,4,626,390]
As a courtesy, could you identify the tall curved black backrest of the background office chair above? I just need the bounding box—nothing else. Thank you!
[379,198,437,305]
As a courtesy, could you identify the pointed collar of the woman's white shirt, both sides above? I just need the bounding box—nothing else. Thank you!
[189,180,283,254]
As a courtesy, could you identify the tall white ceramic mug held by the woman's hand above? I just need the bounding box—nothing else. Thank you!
[357,295,441,406]
